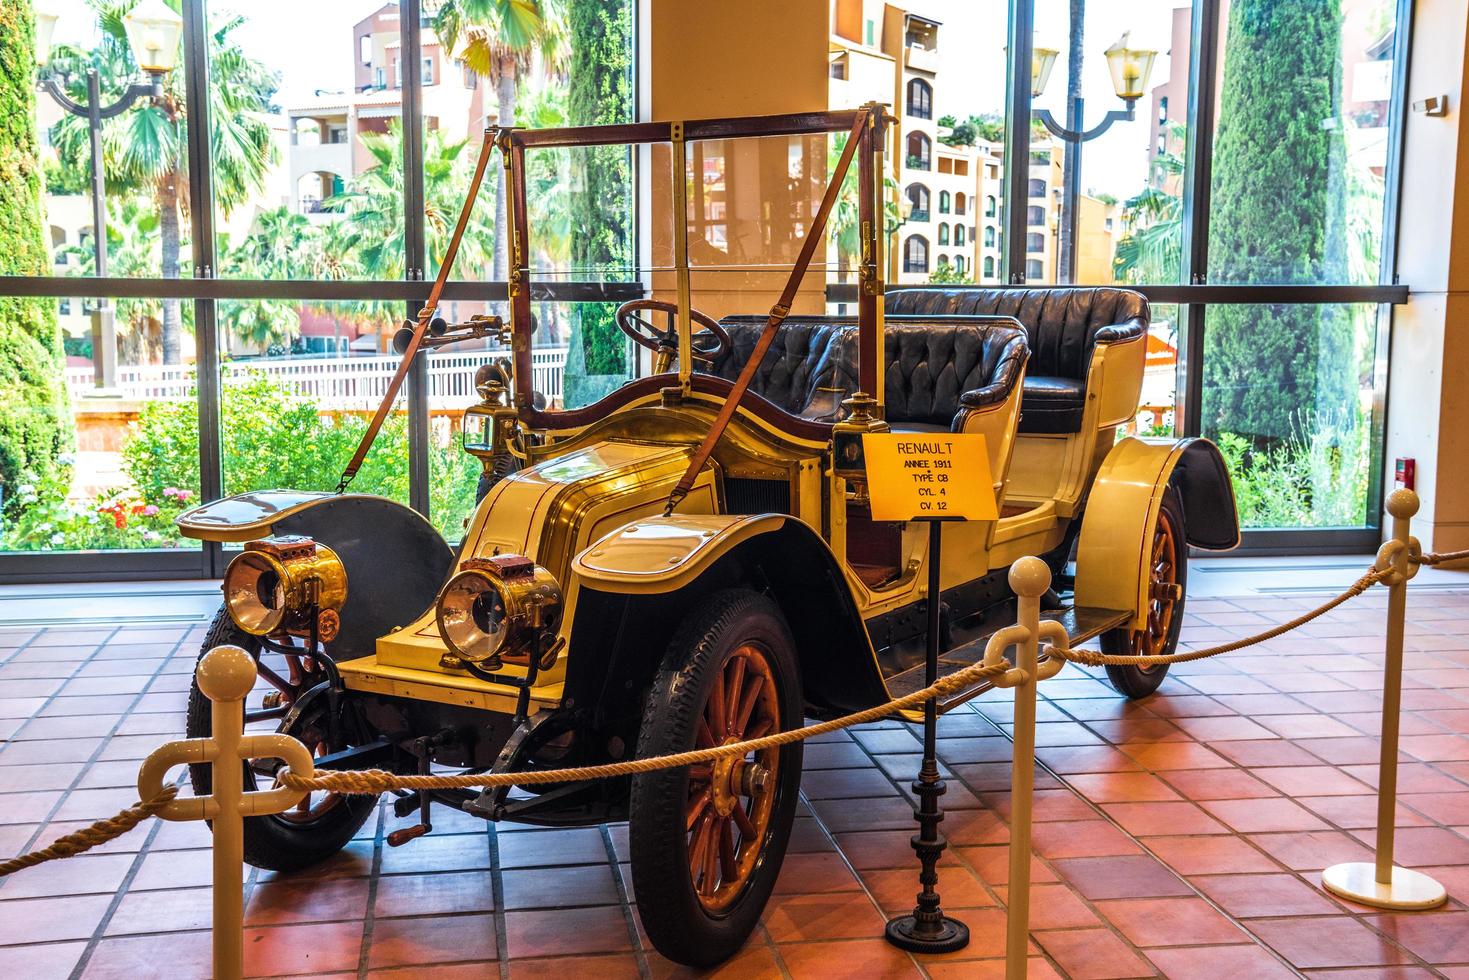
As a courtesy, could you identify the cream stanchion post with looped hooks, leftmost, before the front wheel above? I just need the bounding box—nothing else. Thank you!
[138,645,314,980]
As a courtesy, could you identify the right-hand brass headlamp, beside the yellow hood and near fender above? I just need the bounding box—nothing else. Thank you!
[435,554,561,670]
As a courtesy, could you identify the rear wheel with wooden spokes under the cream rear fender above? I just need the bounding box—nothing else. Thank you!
[1102,488,1188,698]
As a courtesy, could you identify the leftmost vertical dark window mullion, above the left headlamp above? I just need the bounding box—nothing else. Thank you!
[182,0,225,576]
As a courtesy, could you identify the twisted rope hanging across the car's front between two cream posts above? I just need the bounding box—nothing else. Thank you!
[278,663,1009,795]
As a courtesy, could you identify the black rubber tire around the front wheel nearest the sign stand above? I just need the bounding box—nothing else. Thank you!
[629,589,804,967]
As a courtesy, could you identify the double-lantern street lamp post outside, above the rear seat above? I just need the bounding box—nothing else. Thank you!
[1030,32,1158,282]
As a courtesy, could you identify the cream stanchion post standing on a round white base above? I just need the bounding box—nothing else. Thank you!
[1321,489,1448,909]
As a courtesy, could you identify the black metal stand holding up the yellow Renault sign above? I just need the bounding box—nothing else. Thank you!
[886,520,970,952]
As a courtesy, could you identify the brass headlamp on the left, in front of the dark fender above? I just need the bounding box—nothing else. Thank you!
[223,535,347,642]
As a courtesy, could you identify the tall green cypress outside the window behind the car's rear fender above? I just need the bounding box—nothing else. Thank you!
[1202,0,1356,445]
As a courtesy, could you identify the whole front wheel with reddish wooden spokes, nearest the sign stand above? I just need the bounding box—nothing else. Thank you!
[629,589,802,967]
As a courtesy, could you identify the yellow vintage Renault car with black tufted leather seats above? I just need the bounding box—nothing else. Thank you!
[179,106,1238,965]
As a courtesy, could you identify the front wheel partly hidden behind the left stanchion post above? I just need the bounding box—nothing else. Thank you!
[187,608,378,871]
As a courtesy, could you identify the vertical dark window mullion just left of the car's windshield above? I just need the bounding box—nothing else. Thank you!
[400,0,429,517]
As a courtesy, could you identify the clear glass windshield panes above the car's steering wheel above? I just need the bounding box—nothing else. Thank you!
[517,116,861,413]
